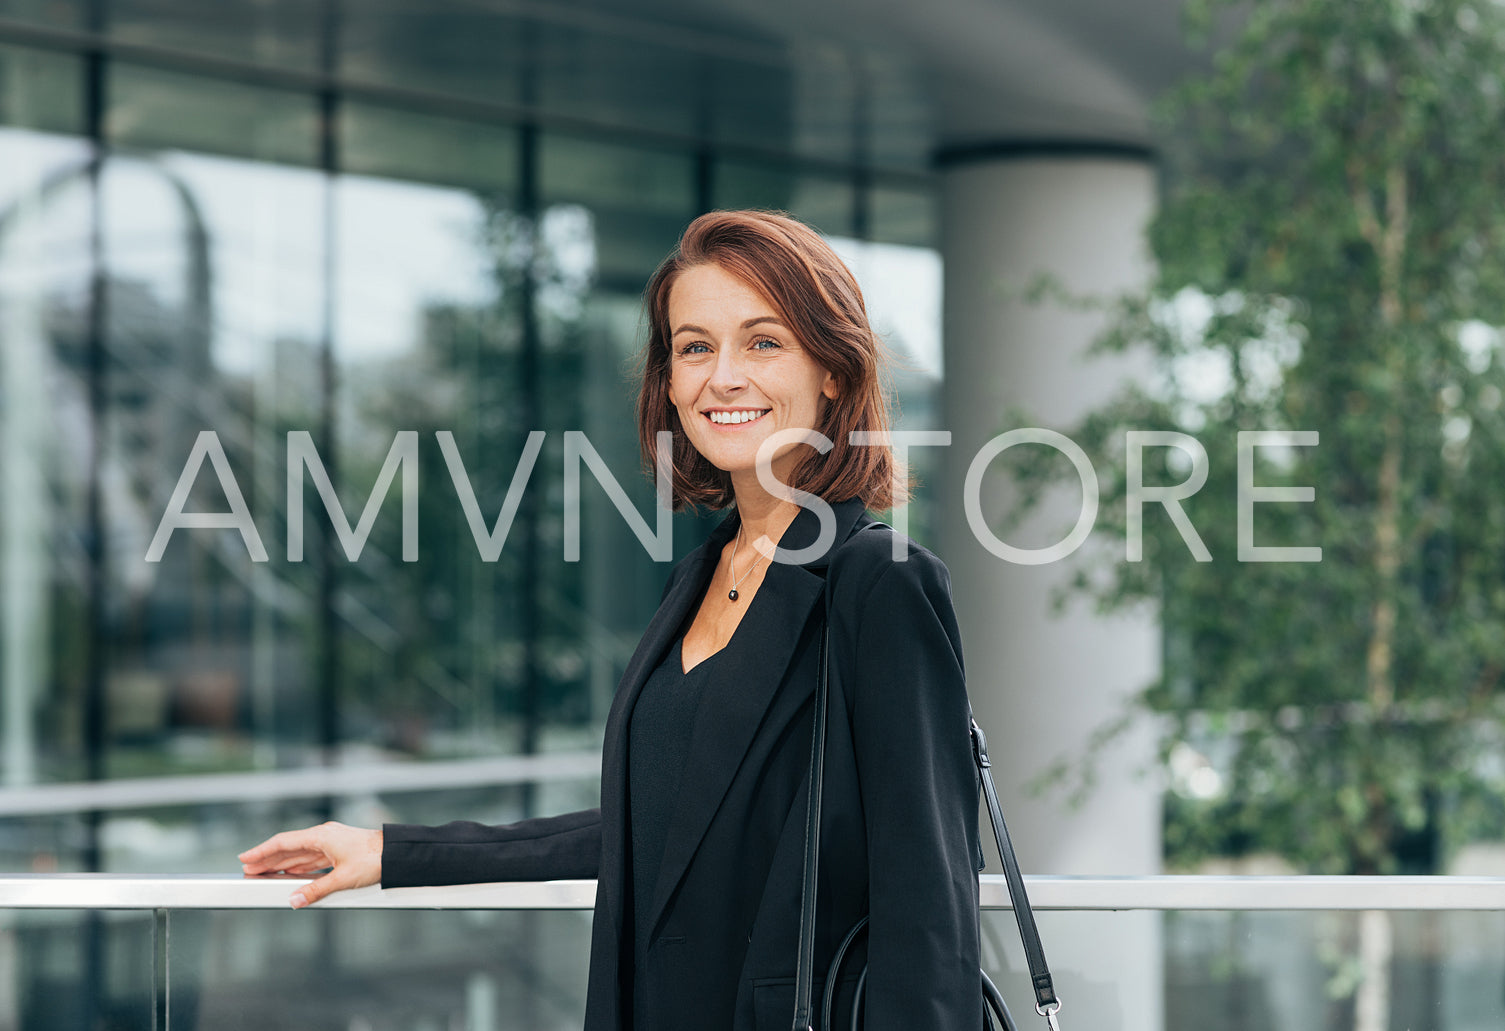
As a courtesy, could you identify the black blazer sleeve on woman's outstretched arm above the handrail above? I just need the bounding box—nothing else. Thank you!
[381,808,600,888]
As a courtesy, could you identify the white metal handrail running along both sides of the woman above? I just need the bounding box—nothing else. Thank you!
[0,873,1505,911]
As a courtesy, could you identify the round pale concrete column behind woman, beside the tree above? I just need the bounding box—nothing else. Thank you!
[939,149,1163,1031]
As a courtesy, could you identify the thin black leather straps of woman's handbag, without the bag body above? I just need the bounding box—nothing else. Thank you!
[792,620,1061,1031]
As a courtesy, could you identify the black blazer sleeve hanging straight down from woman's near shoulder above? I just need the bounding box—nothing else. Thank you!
[843,548,983,1031]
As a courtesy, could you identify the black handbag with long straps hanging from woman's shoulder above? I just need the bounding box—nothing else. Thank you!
[793,622,1061,1031]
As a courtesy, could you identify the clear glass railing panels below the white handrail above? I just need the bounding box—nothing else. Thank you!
[0,909,1505,1031]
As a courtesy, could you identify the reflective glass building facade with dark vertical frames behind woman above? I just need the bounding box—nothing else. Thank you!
[0,0,941,1026]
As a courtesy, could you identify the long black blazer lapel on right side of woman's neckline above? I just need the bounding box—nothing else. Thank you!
[643,501,862,926]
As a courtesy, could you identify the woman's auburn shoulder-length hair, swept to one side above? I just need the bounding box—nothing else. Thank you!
[638,209,909,510]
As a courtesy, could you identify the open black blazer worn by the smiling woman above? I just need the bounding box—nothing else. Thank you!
[382,501,983,1031]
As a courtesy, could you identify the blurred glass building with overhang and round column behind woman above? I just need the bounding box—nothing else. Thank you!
[0,0,1498,1029]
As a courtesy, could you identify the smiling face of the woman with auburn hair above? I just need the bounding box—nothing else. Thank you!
[668,265,837,486]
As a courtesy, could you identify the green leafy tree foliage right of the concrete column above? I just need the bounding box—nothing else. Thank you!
[1023,0,1505,873]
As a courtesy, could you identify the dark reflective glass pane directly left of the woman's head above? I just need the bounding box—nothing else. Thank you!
[537,134,713,764]
